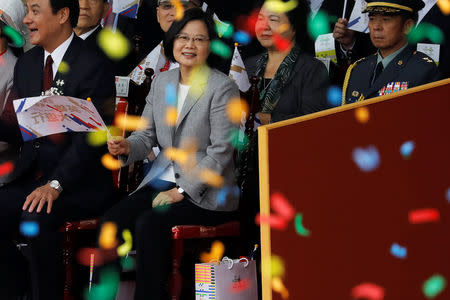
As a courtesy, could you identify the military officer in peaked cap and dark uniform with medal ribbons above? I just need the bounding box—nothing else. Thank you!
[342,0,440,104]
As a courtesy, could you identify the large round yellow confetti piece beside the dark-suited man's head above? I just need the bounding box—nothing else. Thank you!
[97,28,130,60]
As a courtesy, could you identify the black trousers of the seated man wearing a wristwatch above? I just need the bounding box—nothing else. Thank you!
[0,178,114,300]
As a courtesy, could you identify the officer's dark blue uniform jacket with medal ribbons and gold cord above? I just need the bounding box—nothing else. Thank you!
[344,47,440,103]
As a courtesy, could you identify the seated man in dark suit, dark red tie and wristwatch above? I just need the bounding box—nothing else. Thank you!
[0,0,115,300]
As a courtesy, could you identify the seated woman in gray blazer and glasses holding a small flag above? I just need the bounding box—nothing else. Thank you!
[103,8,239,299]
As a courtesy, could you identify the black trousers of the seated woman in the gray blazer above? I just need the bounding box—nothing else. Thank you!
[103,185,236,300]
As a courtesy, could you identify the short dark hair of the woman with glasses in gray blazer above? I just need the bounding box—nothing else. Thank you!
[163,8,218,67]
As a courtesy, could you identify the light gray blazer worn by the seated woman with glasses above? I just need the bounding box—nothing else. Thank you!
[122,66,239,211]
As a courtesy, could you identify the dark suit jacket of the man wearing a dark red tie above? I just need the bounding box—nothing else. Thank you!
[0,36,115,211]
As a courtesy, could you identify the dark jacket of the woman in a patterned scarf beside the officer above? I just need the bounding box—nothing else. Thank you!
[245,52,329,122]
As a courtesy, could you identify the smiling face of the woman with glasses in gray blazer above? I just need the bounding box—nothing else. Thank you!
[173,20,210,68]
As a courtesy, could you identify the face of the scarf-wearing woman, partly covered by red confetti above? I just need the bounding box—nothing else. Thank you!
[255,5,295,50]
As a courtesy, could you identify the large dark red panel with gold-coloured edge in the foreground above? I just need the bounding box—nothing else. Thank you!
[258,79,450,300]
